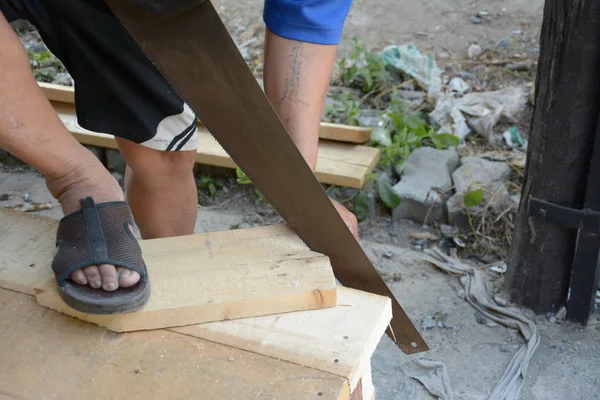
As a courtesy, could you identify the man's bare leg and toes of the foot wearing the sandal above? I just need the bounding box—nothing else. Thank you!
[0,13,139,290]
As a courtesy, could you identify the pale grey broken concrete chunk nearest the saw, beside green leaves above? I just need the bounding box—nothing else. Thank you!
[392,147,458,223]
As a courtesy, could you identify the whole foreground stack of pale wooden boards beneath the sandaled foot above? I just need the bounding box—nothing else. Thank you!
[0,209,391,400]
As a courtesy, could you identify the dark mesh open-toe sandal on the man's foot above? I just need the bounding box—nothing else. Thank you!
[52,197,150,314]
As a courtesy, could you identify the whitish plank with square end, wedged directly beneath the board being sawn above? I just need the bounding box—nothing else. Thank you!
[173,287,392,389]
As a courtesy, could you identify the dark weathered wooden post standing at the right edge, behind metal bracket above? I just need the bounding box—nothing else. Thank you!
[506,0,600,313]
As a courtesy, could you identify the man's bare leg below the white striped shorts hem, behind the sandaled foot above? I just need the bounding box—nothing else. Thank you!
[117,138,198,239]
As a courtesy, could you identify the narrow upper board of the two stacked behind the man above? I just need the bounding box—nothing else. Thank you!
[38,82,371,143]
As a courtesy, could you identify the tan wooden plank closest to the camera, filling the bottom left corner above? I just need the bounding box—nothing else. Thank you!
[0,289,349,400]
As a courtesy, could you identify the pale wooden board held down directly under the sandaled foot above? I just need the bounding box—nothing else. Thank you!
[35,226,337,332]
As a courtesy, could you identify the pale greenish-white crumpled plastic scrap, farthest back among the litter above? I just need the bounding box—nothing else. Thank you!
[381,43,442,98]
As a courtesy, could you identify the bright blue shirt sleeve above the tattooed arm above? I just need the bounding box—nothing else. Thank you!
[263,0,352,44]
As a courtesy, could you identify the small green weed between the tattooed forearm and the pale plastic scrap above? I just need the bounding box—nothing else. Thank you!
[338,37,389,93]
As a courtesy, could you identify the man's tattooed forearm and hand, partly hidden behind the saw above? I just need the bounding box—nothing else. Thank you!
[264,29,358,239]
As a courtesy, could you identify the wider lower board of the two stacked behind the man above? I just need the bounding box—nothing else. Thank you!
[53,103,380,189]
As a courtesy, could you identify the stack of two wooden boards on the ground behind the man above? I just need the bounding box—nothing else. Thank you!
[39,83,380,189]
